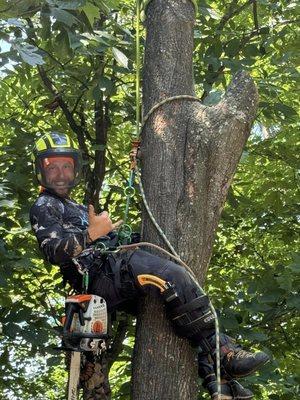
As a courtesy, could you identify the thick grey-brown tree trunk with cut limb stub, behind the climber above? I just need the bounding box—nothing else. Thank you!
[132,0,258,400]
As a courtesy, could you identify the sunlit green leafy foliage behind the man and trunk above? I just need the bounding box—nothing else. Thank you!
[0,0,300,400]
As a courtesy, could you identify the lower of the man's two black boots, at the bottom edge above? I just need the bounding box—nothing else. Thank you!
[198,353,253,400]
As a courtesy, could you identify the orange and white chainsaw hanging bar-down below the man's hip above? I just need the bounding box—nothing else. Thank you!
[60,294,108,400]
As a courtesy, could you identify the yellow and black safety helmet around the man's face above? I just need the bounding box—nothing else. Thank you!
[31,132,82,189]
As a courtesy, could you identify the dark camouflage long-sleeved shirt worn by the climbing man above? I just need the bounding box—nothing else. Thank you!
[30,190,88,266]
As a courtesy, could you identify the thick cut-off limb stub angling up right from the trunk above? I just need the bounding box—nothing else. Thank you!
[186,72,258,281]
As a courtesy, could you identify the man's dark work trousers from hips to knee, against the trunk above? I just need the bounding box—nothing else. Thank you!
[89,250,201,311]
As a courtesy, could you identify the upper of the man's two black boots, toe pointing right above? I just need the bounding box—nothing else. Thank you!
[218,334,269,378]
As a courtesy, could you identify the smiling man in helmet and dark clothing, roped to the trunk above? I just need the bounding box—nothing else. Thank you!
[30,132,268,400]
